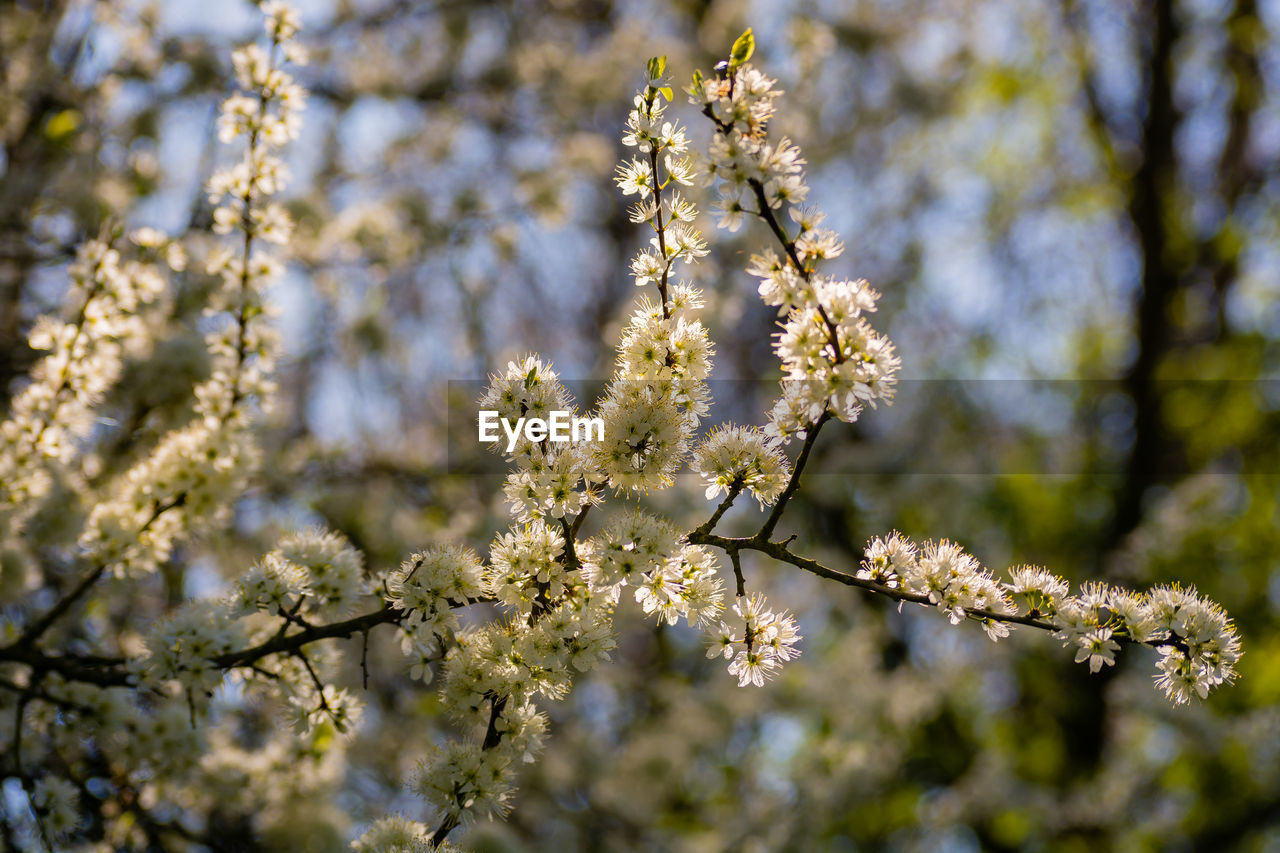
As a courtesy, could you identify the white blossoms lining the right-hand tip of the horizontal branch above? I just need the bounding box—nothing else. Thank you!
[856,533,1242,704]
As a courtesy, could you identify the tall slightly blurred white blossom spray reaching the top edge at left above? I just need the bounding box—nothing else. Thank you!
[81,3,305,575]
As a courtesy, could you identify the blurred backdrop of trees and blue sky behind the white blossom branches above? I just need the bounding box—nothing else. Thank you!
[0,0,1280,852]
